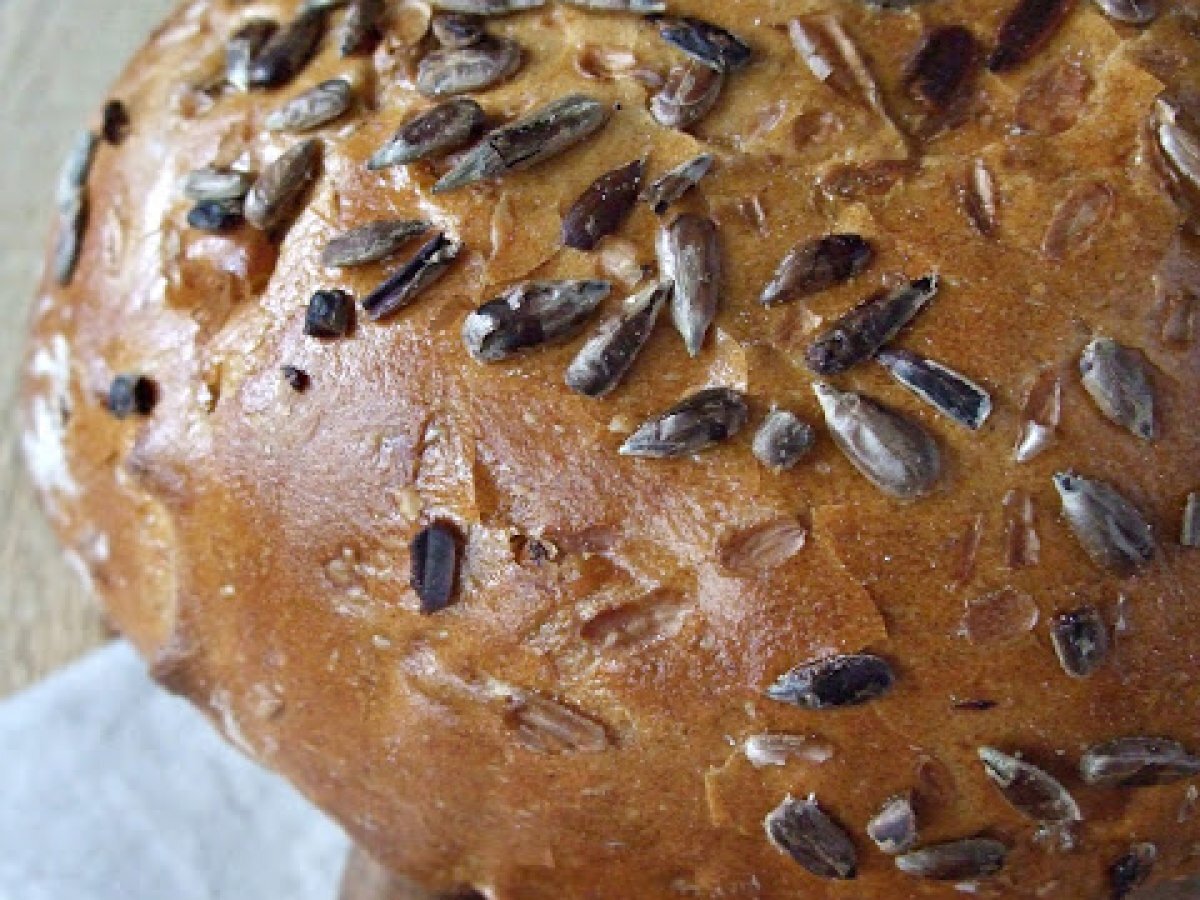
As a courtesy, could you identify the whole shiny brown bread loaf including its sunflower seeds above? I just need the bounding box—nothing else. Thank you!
[25,0,1200,900]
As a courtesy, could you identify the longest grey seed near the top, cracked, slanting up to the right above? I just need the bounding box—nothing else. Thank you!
[433,94,608,193]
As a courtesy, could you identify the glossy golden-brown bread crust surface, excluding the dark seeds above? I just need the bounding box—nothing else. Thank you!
[16,0,1200,900]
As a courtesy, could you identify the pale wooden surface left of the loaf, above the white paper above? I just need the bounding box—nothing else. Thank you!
[0,0,174,696]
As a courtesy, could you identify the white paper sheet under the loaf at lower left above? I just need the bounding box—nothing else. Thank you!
[0,642,348,900]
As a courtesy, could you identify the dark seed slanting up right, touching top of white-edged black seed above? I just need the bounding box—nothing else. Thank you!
[804,275,938,376]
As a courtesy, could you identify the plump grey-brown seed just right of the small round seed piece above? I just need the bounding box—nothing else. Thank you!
[814,383,942,500]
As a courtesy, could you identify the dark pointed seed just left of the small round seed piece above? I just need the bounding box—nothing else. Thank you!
[620,388,750,460]
